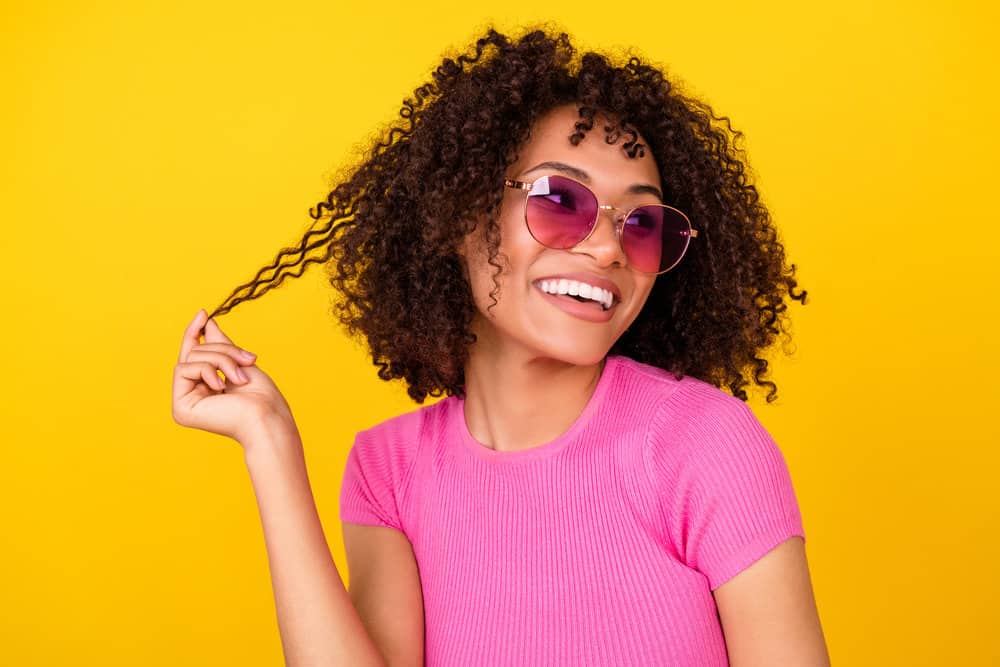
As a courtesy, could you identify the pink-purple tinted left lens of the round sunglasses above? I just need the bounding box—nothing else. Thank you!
[525,176,597,249]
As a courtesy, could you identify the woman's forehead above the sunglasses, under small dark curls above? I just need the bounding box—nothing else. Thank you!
[512,104,660,187]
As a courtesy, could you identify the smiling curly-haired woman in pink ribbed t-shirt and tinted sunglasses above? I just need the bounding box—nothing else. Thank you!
[173,24,829,666]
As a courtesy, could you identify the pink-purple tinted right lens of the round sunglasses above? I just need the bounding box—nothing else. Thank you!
[622,205,691,273]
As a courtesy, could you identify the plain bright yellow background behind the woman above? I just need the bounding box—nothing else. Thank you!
[0,0,1000,666]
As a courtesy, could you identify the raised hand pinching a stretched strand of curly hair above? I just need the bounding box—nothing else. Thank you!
[172,309,294,444]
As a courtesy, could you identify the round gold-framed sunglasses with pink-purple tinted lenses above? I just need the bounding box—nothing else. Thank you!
[503,175,698,274]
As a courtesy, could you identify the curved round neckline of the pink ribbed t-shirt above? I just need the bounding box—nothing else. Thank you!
[449,355,619,464]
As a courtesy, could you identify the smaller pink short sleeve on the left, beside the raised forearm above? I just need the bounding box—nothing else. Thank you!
[340,431,403,530]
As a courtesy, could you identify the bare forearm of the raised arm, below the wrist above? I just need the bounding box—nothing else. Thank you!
[242,419,385,667]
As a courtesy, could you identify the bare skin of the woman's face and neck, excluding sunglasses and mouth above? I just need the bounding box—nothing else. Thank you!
[460,105,662,451]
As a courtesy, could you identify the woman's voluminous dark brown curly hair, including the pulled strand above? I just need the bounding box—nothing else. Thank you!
[203,27,806,403]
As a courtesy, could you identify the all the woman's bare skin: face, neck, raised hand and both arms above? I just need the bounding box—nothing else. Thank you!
[172,106,830,667]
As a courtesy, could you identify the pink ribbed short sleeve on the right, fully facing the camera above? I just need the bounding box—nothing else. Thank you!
[653,387,805,590]
